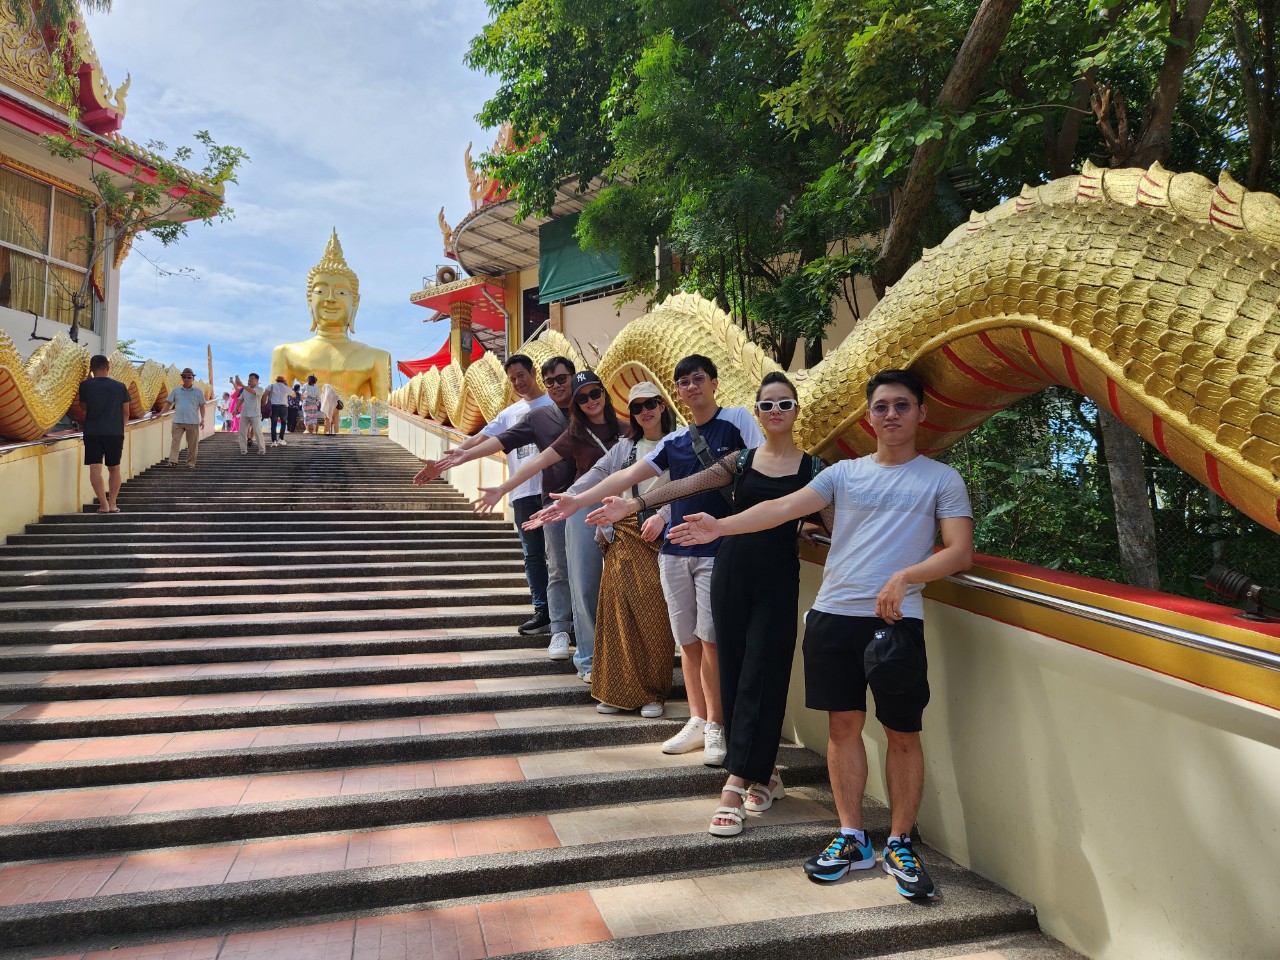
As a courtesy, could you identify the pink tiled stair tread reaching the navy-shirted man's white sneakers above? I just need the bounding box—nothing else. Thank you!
[0,704,689,790]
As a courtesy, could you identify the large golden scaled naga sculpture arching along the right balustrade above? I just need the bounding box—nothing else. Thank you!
[393,164,1280,542]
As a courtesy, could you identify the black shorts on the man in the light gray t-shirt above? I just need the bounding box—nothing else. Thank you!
[804,611,929,733]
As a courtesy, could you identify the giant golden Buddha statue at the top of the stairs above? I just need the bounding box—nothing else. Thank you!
[271,228,392,398]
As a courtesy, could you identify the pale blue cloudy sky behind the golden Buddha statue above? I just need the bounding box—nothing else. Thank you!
[88,0,495,394]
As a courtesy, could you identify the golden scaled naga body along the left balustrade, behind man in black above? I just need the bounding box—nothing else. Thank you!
[0,330,214,442]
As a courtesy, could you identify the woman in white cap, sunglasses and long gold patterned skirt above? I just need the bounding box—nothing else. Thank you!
[530,383,676,717]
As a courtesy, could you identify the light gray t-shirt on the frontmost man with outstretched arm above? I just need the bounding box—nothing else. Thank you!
[809,456,973,620]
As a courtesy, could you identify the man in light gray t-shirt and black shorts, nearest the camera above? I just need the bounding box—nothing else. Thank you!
[668,370,973,900]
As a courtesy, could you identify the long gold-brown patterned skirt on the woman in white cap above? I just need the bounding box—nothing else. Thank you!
[591,517,676,710]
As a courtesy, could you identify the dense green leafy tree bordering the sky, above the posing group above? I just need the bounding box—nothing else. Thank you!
[468,0,870,365]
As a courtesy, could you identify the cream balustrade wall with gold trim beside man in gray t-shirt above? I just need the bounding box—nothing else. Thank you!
[783,562,1280,960]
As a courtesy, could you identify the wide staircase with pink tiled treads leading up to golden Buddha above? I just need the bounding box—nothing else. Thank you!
[0,435,1074,960]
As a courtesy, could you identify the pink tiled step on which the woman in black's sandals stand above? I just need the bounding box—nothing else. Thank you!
[0,742,824,861]
